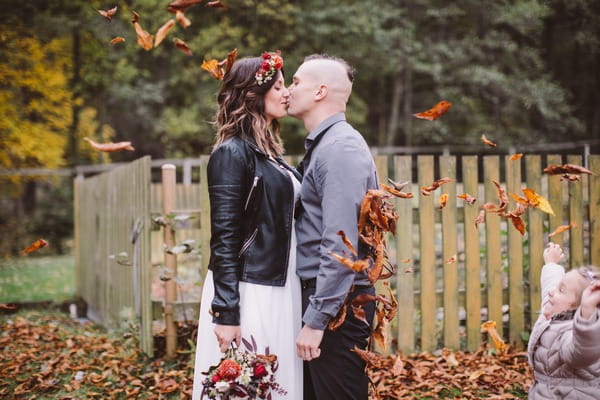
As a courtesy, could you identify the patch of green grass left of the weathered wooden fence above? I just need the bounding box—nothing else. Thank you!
[0,255,77,303]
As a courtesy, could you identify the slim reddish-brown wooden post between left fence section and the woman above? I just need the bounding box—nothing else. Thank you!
[162,164,177,358]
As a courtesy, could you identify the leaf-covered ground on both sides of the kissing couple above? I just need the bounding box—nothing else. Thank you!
[0,311,531,400]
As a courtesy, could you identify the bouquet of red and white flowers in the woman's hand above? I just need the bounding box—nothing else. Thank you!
[202,339,286,400]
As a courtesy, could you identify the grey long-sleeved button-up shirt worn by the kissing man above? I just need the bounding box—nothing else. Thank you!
[296,113,379,329]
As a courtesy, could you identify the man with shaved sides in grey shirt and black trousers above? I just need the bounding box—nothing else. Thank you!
[288,55,378,400]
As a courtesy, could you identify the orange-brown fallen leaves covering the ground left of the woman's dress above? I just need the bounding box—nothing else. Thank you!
[0,311,193,399]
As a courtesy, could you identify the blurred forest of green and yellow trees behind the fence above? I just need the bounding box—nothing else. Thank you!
[0,0,600,256]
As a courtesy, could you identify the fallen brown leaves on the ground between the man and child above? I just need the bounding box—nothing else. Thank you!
[364,347,533,400]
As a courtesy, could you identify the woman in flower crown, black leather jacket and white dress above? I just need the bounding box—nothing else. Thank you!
[192,52,302,400]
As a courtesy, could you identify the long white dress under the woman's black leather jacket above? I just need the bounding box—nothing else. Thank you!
[192,171,303,400]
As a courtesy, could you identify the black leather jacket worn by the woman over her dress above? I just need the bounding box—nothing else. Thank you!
[208,137,300,325]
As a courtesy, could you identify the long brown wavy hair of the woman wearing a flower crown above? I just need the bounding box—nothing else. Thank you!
[215,57,283,156]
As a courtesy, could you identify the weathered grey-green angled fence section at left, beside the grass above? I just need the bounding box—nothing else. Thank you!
[74,157,152,354]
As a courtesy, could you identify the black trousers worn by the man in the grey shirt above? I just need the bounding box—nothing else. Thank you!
[302,286,375,400]
